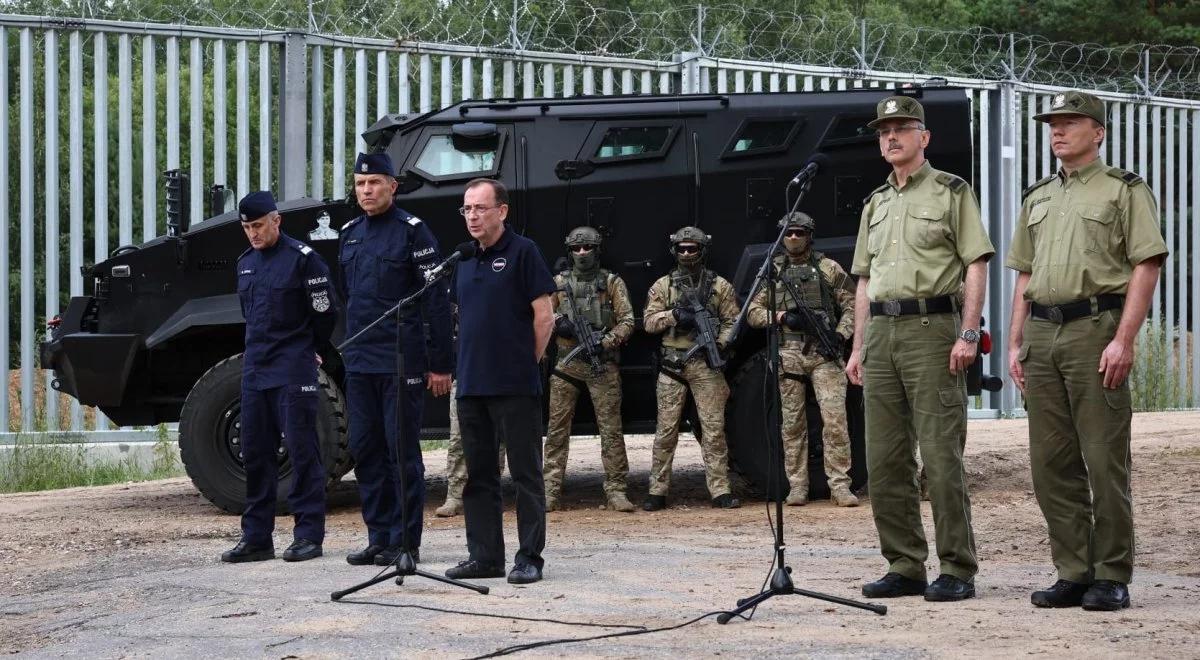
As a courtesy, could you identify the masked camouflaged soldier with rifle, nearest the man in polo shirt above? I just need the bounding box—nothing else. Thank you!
[542,227,634,511]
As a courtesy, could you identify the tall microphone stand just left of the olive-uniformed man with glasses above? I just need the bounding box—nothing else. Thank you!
[716,171,888,624]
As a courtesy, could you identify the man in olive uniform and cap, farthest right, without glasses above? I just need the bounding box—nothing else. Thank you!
[1007,91,1168,610]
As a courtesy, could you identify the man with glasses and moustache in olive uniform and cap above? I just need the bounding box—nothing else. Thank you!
[846,96,995,601]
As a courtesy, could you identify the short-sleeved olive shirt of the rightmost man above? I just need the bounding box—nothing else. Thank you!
[1006,158,1166,305]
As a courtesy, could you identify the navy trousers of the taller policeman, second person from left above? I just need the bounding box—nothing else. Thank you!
[346,372,425,550]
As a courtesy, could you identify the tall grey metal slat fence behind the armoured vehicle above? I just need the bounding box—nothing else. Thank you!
[0,14,1200,431]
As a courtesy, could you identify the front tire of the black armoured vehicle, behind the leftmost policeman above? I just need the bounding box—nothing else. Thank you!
[179,354,353,514]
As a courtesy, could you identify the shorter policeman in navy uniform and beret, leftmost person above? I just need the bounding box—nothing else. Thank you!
[221,191,337,563]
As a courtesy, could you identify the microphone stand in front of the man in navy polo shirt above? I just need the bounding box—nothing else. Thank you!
[329,260,488,601]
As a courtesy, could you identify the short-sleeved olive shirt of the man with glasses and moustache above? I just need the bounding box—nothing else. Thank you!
[851,161,996,301]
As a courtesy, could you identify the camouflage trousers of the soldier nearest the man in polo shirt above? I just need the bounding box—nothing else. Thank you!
[542,361,629,498]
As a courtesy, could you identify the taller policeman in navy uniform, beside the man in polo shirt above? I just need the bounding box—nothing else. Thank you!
[338,154,451,565]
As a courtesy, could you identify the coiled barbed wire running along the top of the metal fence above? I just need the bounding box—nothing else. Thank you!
[7,0,1200,98]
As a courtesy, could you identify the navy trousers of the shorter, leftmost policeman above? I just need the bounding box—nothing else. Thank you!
[241,385,325,544]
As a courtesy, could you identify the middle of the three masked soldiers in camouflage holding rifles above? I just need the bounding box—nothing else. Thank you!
[642,227,742,511]
